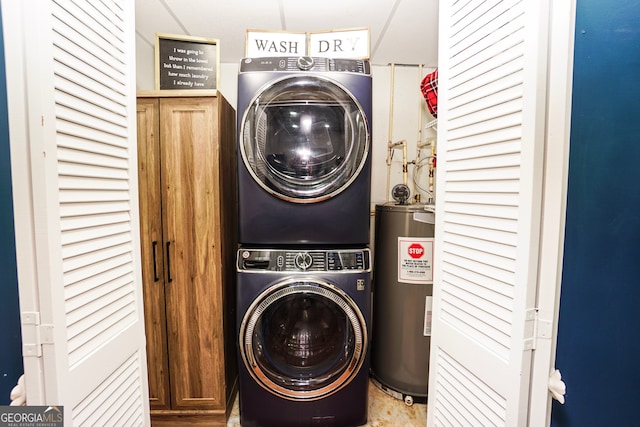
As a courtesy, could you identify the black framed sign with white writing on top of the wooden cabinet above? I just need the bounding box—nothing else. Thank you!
[155,33,220,90]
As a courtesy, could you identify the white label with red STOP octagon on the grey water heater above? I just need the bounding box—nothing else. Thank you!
[398,237,433,284]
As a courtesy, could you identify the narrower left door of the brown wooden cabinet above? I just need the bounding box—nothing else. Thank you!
[137,98,170,409]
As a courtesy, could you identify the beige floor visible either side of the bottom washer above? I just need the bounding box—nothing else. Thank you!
[227,382,427,427]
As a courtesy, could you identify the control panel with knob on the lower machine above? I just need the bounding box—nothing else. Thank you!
[237,249,371,272]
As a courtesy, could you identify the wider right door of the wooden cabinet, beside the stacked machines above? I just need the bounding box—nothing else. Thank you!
[160,98,225,409]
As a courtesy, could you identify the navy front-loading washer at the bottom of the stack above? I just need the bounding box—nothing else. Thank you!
[237,249,371,427]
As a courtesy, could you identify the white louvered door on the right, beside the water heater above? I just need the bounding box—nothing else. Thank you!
[428,0,548,427]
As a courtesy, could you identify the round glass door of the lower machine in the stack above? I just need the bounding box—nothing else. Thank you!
[239,279,367,400]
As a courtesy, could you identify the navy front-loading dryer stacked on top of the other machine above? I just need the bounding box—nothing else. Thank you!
[238,57,371,247]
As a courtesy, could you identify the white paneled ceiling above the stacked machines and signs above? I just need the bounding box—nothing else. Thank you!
[135,0,438,66]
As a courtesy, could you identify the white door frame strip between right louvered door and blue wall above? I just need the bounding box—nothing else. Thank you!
[529,0,576,426]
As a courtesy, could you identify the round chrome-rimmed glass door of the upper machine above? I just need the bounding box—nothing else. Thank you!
[240,75,369,203]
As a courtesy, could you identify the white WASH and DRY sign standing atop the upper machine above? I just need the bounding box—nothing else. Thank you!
[245,28,370,59]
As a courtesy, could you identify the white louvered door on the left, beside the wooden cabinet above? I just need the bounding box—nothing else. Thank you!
[2,0,149,426]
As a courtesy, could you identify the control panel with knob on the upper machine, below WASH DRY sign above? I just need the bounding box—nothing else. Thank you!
[240,56,371,74]
